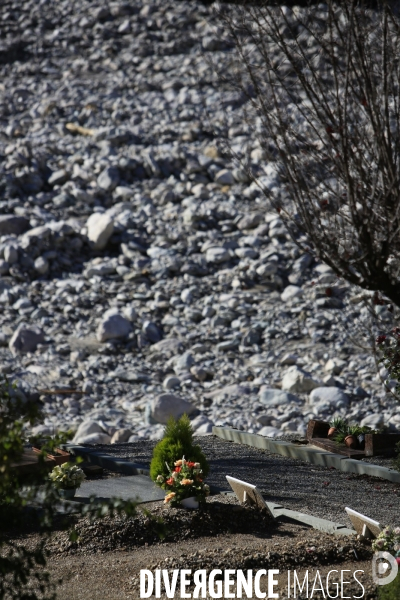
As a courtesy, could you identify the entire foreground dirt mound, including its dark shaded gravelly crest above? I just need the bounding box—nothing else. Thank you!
[12,496,376,600]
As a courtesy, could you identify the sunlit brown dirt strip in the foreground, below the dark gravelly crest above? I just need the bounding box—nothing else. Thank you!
[44,523,376,600]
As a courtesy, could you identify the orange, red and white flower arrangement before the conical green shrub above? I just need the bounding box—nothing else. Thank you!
[156,457,210,506]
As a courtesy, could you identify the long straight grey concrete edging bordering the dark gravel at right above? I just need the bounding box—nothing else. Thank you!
[212,427,400,483]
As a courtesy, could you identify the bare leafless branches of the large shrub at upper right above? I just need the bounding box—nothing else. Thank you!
[217,0,400,306]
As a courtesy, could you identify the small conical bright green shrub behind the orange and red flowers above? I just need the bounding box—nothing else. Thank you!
[150,415,210,481]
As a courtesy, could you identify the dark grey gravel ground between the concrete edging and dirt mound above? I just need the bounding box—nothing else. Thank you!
[79,436,400,525]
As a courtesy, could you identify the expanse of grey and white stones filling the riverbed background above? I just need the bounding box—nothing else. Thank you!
[0,0,400,443]
